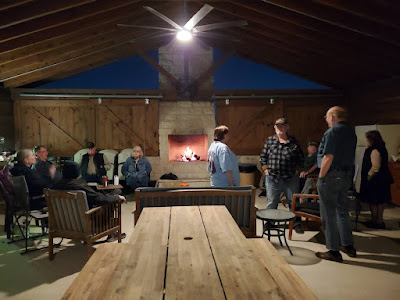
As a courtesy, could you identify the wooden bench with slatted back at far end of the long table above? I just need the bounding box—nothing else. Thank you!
[134,186,256,237]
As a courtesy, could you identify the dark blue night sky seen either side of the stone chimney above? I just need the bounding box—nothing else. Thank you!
[38,50,327,90]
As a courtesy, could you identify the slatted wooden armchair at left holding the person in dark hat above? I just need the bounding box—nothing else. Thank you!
[44,190,121,260]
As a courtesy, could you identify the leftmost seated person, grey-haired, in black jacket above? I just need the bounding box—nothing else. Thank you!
[10,149,56,210]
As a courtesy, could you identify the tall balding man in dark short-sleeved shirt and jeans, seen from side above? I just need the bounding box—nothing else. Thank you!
[316,106,357,262]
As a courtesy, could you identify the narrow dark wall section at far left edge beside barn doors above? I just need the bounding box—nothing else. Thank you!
[0,88,14,151]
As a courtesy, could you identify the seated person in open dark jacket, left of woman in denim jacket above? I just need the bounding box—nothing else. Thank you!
[81,142,111,184]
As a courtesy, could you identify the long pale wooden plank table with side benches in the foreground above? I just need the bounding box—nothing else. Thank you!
[63,206,316,299]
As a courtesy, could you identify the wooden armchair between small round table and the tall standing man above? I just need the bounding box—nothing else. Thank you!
[289,194,321,240]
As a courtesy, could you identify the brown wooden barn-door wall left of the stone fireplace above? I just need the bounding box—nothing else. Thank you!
[14,99,159,156]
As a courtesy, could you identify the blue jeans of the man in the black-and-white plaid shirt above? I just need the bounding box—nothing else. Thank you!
[265,175,299,209]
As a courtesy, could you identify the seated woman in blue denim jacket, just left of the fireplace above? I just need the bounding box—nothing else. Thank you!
[121,146,151,189]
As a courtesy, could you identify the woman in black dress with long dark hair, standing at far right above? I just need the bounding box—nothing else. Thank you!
[360,130,394,229]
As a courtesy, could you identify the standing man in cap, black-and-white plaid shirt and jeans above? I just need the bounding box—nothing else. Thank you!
[260,118,304,233]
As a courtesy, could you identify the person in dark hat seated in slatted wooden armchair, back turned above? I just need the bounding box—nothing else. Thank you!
[53,161,126,242]
